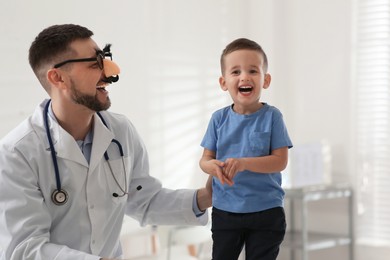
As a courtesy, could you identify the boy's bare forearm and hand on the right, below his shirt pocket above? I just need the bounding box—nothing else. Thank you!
[224,147,288,179]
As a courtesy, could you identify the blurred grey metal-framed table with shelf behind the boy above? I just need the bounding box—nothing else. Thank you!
[282,185,354,260]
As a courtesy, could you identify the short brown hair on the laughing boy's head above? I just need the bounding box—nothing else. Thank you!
[220,38,268,74]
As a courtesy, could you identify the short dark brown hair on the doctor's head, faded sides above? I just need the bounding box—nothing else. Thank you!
[28,24,93,90]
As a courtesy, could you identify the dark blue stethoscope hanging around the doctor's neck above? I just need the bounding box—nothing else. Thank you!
[44,100,129,206]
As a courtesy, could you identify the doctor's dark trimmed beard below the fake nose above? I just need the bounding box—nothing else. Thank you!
[71,80,111,112]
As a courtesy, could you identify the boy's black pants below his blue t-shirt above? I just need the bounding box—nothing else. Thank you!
[211,207,286,260]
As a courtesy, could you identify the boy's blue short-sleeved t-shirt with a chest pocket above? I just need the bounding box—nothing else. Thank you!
[201,103,292,213]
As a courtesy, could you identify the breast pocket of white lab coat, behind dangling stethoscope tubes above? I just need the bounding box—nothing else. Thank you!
[104,155,130,203]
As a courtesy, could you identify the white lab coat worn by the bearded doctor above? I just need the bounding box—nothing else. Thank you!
[0,100,207,260]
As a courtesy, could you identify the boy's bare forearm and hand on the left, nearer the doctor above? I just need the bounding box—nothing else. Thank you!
[199,148,233,186]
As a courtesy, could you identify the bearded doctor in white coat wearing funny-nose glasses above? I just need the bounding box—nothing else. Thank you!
[0,24,211,260]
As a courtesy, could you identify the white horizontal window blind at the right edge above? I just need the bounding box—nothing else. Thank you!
[353,0,390,245]
